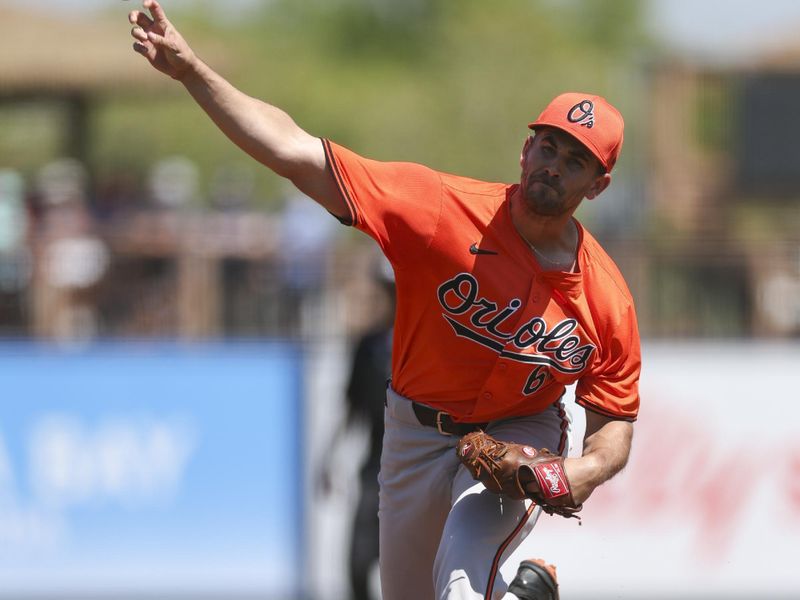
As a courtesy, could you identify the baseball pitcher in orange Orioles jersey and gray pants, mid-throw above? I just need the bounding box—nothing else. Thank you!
[129,0,640,600]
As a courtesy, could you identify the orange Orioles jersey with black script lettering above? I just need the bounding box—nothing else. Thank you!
[323,140,641,422]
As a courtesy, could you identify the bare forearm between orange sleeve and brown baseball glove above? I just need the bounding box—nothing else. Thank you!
[564,410,633,504]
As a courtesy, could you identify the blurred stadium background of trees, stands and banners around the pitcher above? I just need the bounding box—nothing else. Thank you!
[0,0,800,600]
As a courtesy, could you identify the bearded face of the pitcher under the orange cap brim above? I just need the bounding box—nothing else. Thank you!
[520,127,611,217]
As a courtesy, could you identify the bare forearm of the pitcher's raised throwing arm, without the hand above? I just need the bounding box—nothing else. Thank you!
[180,59,324,179]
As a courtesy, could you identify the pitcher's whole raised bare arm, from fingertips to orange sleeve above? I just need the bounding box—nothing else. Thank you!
[128,0,348,217]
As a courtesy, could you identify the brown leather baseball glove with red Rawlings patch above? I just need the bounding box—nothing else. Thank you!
[456,430,583,518]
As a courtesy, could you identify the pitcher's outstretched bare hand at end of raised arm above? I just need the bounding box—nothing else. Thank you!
[128,0,196,79]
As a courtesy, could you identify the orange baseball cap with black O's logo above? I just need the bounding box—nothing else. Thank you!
[528,92,625,171]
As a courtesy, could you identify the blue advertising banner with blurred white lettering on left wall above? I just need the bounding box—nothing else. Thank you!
[0,343,303,599]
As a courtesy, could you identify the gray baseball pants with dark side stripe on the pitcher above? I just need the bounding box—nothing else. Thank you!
[378,387,569,600]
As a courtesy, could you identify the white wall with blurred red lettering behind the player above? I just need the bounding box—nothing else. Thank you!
[309,342,800,600]
